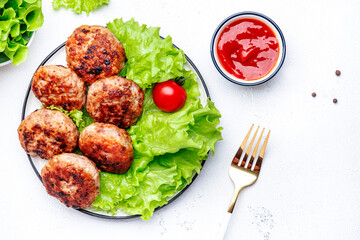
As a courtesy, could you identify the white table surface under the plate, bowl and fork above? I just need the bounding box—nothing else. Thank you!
[0,0,360,240]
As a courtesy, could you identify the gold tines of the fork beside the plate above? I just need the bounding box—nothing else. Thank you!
[232,124,270,172]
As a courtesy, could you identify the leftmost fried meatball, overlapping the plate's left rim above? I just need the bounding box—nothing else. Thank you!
[18,108,79,159]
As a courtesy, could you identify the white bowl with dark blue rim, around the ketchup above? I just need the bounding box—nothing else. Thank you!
[210,12,286,86]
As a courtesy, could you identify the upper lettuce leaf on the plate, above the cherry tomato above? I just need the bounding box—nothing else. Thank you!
[107,19,186,89]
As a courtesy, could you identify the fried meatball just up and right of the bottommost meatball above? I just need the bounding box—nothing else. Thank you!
[79,123,134,173]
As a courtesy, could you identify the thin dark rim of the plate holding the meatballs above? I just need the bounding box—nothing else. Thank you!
[21,42,210,219]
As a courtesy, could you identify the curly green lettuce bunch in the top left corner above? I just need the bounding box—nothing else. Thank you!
[0,0,44,65]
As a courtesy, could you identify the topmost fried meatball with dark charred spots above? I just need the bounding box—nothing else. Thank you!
[65,25,126,84]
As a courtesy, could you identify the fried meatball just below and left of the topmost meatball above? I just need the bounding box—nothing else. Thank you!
[31,65,86,111]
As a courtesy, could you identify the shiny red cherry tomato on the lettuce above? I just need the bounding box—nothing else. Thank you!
[153,80,186,112]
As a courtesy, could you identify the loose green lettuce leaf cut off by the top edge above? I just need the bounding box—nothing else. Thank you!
[52,0,110,15]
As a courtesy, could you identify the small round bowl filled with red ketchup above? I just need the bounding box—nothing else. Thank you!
[210,12,286,86]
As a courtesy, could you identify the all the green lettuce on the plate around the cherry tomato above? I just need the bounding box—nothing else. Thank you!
[92,19,222,220]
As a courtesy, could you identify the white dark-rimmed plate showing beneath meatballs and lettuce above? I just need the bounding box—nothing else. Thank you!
[22,43,210,219]
